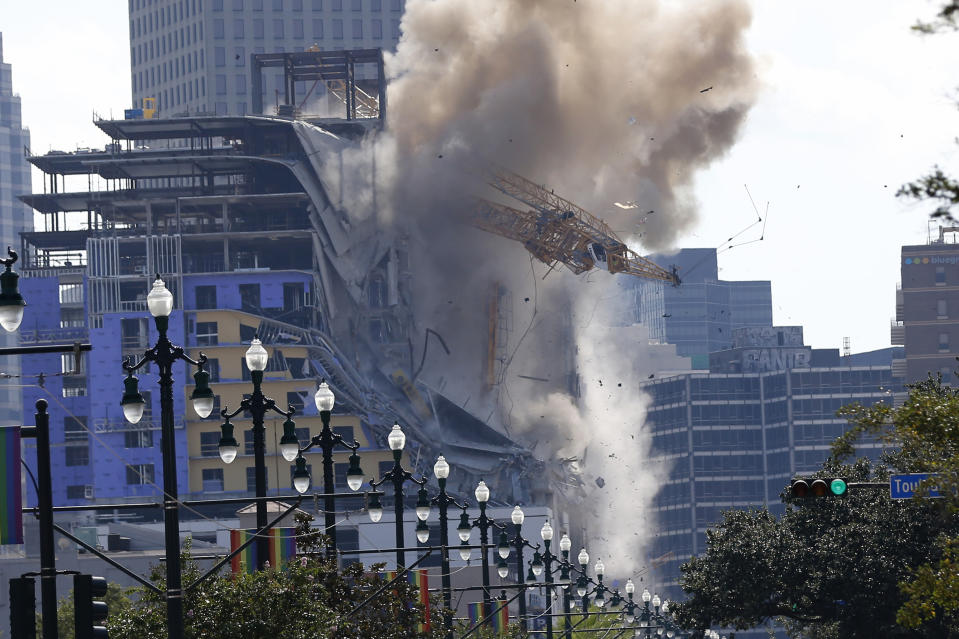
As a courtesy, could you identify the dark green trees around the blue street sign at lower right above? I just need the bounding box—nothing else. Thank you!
[673,378,959,639]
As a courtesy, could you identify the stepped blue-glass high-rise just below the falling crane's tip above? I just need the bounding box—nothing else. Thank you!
[622,248,773,369]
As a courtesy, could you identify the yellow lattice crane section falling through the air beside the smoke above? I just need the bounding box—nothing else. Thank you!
[469,168,680,286]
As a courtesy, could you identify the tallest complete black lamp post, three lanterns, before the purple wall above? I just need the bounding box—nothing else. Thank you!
[121,275,213,639]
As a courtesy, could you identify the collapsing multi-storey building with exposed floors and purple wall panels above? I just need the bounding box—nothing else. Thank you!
[21,50,545,510]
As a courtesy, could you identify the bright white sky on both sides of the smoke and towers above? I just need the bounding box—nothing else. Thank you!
[0,0,959,351]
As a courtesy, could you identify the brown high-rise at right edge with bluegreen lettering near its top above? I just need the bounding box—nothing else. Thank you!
[891,227,959,384]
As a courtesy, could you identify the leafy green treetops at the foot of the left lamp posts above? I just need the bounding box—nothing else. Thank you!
[107,516,454,639]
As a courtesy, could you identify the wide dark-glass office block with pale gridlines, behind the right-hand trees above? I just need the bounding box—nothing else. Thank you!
[643,326,902,612]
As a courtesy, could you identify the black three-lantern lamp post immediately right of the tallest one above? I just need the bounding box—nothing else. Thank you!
[219,336,296,570]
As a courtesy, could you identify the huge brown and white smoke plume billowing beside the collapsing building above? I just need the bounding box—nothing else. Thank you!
[381,0,755,576]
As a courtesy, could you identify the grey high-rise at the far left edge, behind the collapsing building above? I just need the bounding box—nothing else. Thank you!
[0,33,33,424]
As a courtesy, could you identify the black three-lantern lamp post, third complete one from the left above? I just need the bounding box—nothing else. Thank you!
[288,380,363,549]
